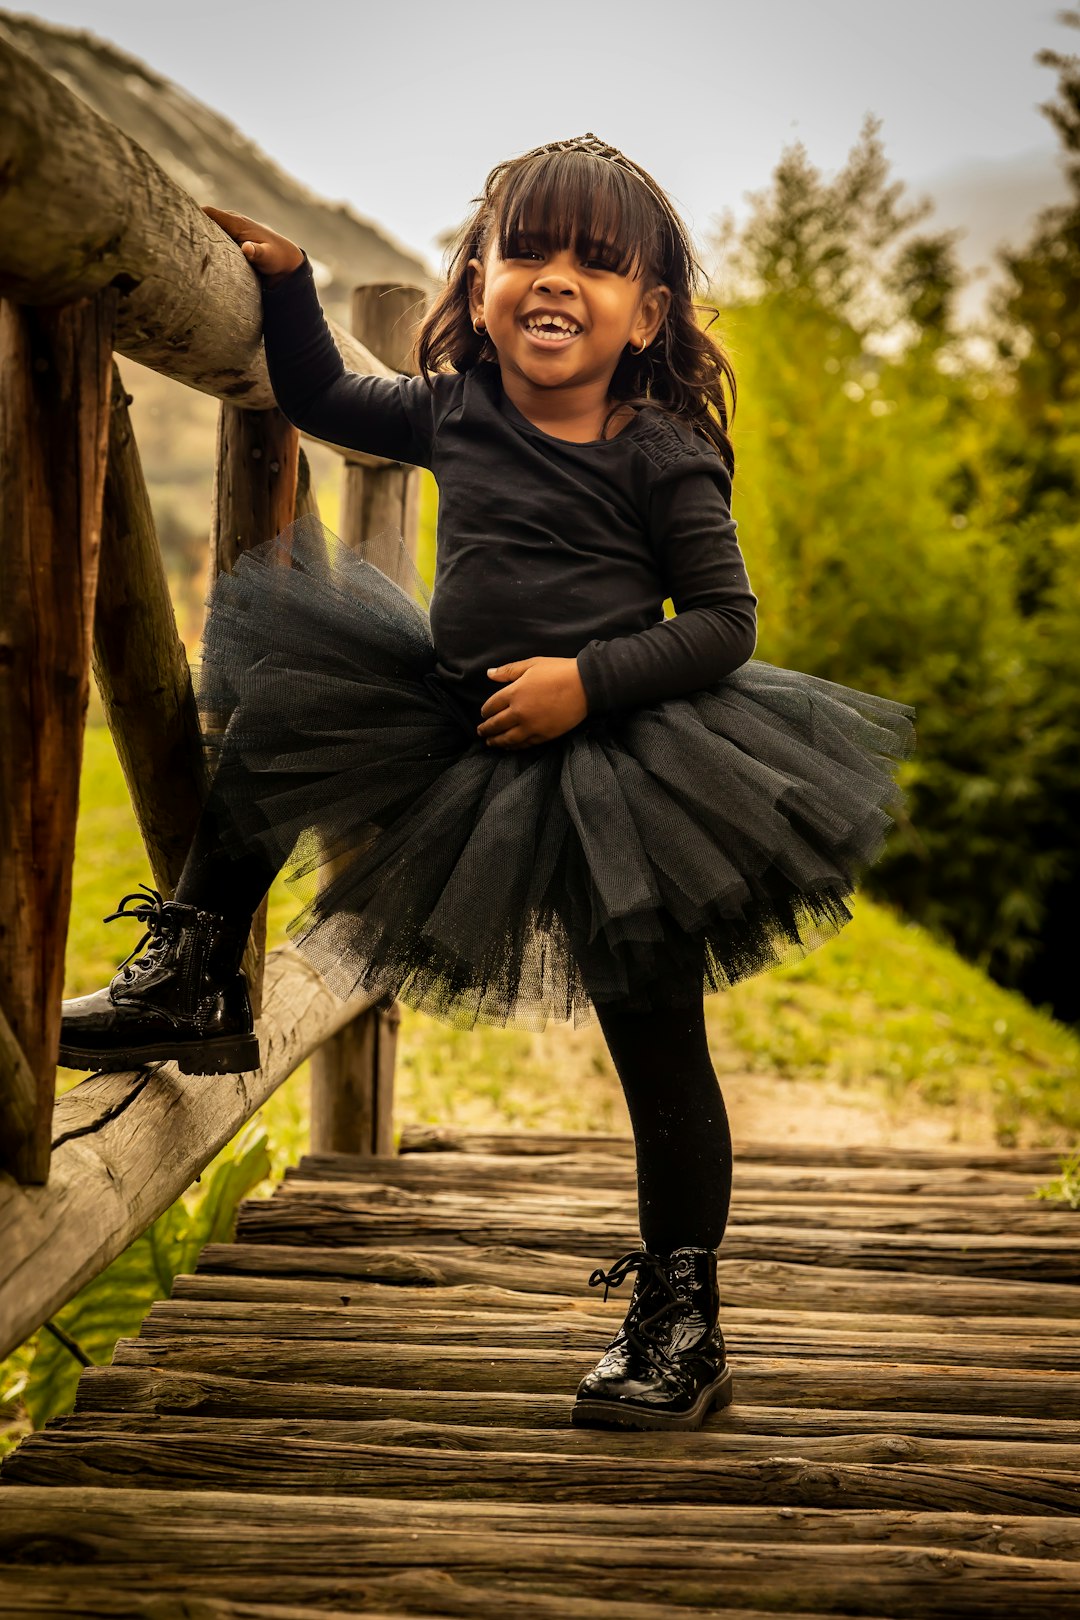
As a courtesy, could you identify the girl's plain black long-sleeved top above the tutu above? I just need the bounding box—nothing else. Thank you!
[261,254,756,714]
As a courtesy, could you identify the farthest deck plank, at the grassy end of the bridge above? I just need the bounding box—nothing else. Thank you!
[398,1124,1061,1176]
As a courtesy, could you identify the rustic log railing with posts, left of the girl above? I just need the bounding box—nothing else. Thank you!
[0,39,424,1356]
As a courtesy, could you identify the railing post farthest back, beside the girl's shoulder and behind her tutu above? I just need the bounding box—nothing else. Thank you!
[311,282,426,1153]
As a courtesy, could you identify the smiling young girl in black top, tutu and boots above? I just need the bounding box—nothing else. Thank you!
[62,134,913,1429]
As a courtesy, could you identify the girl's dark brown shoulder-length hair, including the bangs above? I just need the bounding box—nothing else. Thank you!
[415,136,735,473]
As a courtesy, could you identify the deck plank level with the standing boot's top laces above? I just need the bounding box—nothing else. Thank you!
[198,1243,1080,1322]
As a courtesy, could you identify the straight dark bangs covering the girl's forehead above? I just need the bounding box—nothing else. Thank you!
[495,151,662,275]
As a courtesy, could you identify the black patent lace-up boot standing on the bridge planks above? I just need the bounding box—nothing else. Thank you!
[572,1249,732,1429]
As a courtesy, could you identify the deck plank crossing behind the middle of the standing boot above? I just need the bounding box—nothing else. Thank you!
[139,1299,1080,1372]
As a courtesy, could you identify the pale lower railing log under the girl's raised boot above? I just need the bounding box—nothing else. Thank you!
[0,944,369,1359]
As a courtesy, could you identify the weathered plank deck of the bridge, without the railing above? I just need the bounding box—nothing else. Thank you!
[0,1129,1080,1620]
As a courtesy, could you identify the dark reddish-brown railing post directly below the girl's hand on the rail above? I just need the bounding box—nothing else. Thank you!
[210,403,300,1017]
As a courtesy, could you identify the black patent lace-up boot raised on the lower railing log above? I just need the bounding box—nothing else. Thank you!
[60,883,259,1074]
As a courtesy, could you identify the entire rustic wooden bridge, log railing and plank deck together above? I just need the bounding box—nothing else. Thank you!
[0,25,1080,1620]
